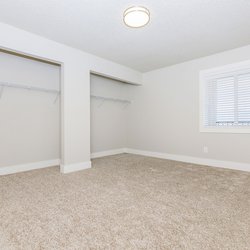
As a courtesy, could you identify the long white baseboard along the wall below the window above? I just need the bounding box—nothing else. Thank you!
[125,148,250,172]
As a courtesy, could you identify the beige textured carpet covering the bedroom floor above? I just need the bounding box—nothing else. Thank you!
[0,154,250,250]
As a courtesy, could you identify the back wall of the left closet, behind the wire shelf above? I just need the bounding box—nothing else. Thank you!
[0,52,60,167]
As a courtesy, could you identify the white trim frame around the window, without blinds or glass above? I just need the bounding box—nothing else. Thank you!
[199,60,250,134]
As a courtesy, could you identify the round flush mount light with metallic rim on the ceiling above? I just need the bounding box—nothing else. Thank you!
[123,6,150,28]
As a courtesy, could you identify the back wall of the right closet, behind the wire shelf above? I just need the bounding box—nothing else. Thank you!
[90,75,130,153]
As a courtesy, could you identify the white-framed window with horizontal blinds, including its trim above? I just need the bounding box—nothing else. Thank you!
[200,61,250,133]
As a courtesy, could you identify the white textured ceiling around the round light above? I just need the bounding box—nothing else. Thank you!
[0,0,250,72]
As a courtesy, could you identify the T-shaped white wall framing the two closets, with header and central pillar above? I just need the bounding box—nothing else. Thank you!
[0,23,142,169]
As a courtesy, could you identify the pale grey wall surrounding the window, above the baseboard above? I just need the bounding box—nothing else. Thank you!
[128,46,250,163]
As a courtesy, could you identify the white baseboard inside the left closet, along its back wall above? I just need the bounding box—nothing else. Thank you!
[0,159,60,175]
